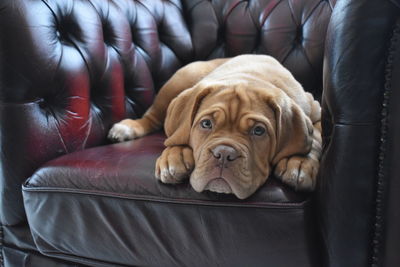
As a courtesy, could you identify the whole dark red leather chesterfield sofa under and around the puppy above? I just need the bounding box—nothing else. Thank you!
[0,0,400,267]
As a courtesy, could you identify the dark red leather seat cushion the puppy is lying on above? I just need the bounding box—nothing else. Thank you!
[23,133,317,266]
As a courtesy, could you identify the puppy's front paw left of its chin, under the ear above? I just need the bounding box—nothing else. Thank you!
[155,146,194,184]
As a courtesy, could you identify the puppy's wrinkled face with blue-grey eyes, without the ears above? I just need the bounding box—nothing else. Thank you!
[189,86,276,199]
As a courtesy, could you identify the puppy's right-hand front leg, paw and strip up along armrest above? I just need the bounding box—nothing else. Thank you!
[274,122,322,191]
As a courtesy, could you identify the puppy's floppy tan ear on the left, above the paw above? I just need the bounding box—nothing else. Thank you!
[164,86,211,146]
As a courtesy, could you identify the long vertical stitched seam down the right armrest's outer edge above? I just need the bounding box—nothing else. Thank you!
[371,20,400,267]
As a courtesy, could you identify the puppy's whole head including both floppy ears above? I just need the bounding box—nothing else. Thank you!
[165,84,312,199]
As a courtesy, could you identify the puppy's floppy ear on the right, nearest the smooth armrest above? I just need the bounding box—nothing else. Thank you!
[268,97,314,164]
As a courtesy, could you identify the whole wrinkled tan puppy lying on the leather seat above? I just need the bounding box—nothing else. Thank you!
[108,55,321,199]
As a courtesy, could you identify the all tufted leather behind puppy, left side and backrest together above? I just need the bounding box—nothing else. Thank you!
[0,0,335,224]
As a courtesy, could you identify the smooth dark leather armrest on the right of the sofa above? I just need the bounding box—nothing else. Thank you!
[317,0,400,267]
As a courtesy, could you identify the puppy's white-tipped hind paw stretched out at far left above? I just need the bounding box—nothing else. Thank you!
[108,119,143,142]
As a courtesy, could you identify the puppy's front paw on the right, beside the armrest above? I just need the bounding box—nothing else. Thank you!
[274,156,319,191]
